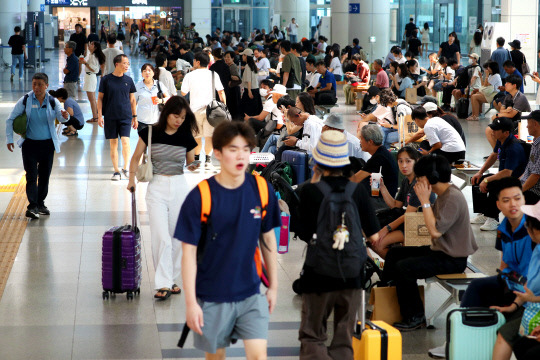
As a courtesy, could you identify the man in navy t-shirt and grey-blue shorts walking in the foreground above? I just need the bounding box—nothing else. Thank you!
[174,122,281,359]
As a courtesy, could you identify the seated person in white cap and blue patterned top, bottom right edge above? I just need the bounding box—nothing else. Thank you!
[493,202,540,360]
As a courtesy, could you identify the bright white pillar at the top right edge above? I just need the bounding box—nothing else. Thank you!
[501,0,538,93]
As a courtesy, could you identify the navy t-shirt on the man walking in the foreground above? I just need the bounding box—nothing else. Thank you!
[174,175,281,302]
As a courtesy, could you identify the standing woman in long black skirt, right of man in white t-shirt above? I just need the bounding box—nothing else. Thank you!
[240,49,262,117]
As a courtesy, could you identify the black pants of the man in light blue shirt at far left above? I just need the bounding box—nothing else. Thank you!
[22,139,54,209]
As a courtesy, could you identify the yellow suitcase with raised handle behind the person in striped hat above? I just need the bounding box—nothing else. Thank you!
[353,289,402,360]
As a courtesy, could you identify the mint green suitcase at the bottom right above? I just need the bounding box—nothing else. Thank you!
[446,308,506,360]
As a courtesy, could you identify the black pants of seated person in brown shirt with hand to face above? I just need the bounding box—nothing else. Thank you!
[382,246,467,321]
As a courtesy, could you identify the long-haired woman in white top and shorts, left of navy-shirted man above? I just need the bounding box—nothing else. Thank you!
[79,41,105,122]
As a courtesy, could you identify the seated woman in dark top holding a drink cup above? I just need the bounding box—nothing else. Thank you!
[371,146,435,259]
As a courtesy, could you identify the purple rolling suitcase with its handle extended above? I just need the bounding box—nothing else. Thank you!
[101,192,142,300]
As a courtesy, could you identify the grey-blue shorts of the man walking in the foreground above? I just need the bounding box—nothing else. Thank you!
[193,294,270,354]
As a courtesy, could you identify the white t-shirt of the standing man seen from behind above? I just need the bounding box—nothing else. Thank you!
[181,69,223,112]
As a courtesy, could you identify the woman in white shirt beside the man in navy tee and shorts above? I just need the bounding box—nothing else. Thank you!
[135,64,169,133]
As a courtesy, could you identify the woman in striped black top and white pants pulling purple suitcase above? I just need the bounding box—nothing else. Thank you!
[127,96,199,300]
